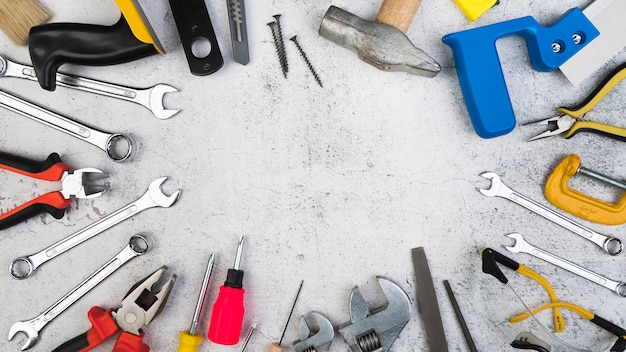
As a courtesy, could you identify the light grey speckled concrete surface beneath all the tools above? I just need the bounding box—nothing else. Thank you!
[0,0,626,352]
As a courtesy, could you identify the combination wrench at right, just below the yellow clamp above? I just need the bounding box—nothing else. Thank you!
[480,172,624,255]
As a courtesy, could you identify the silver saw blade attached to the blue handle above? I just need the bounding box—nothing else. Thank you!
[560,0,626,86]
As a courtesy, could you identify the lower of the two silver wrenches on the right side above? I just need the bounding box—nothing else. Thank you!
[504,233,626,297]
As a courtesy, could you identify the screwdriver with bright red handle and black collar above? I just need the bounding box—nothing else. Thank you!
[208,236,246,345]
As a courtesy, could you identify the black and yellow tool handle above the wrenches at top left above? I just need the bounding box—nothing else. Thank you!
[28,0,165,90]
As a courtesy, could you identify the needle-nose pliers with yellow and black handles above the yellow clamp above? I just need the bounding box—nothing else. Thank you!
[527,63,626,142]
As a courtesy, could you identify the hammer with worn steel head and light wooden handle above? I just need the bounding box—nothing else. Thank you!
[319,0,441,77]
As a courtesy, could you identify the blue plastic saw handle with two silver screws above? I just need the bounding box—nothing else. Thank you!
[442,7,604,138]
